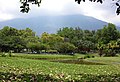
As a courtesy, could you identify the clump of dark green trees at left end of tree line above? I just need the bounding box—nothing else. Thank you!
[0,26,34,52]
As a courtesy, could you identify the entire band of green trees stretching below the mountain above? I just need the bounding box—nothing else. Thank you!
[0,23,120,56]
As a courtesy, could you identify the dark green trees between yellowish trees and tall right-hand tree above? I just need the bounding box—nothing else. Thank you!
[57,27,96,53]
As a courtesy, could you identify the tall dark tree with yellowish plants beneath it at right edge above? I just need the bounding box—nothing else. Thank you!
[96,23,120,56]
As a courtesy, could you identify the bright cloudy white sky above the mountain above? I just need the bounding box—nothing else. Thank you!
[0,0,120,25]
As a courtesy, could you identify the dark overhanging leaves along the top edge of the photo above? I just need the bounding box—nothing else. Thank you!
[20,0,120,15]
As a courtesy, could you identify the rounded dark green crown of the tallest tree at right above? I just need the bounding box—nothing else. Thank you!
[96,23,119,44]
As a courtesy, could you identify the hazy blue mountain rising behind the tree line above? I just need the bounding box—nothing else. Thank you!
[0,15,107,34]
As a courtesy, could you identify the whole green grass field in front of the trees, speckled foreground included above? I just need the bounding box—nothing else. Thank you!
[0,53,120,82]
